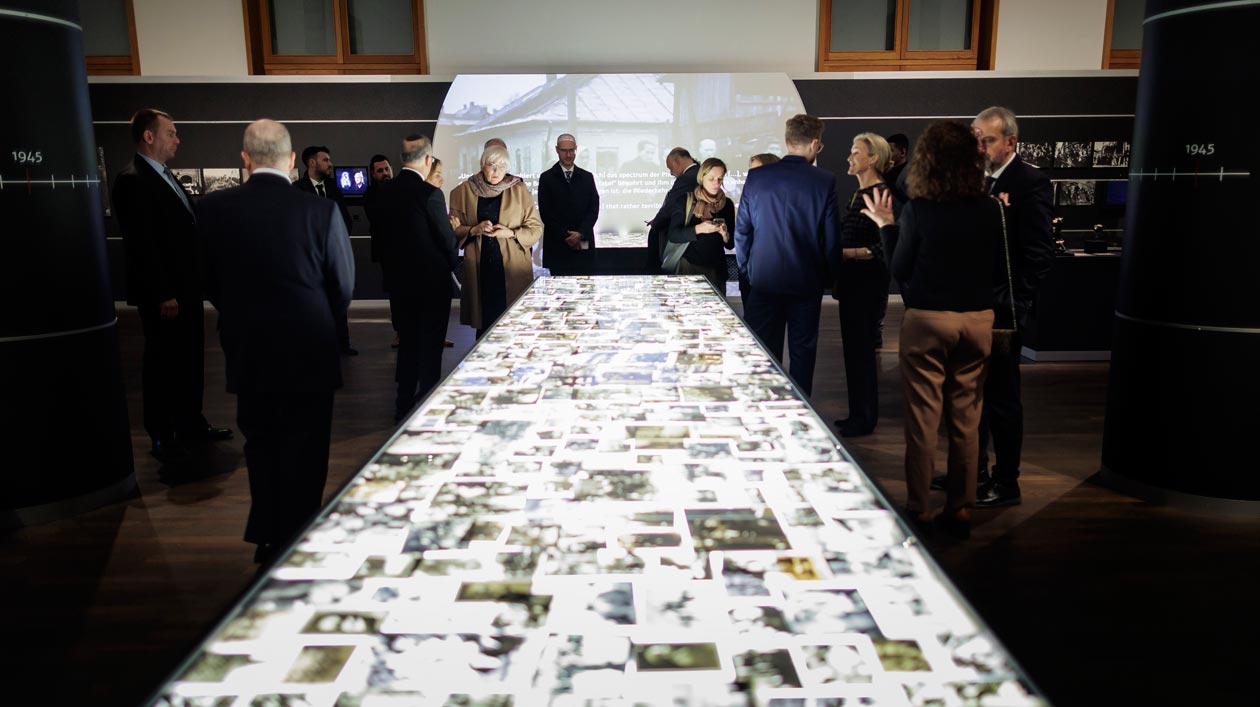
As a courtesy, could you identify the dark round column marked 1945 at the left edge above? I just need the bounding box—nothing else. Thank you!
[0,0,135,526]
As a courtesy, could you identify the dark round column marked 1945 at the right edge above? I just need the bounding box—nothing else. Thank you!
[1103,0,1260,500]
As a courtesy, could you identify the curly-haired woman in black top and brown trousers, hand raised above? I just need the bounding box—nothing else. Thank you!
[862,122,1008,537]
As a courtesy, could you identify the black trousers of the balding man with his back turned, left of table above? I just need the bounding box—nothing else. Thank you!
[237,391,333,544]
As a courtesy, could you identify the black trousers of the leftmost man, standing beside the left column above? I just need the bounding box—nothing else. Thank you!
[137,297,205,441]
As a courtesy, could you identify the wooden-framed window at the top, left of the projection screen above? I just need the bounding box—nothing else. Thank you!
[242,0,428,74]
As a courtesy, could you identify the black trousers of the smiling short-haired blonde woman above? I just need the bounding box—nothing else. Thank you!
[835,260,888,427]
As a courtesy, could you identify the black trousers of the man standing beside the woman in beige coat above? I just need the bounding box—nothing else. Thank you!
[389,290,451,420]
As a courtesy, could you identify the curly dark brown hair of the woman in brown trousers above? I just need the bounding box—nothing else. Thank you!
[906,121,984,202]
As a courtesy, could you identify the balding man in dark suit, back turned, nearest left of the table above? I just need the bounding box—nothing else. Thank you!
[198,120,354,562]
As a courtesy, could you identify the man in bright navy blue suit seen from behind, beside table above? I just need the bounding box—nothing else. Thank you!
[735,115,840,394]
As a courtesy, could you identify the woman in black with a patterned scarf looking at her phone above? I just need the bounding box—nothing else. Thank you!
[667,158,735,296]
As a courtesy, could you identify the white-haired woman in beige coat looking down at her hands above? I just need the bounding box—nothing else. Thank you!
[451,146,543,338]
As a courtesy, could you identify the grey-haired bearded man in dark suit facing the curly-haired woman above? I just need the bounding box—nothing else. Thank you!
[971,107,1055,508]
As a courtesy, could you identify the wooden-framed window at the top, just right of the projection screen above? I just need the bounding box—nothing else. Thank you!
[818,0,998,72]
